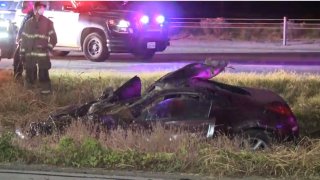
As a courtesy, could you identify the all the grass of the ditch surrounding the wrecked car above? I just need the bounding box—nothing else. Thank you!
[0,71,320,177]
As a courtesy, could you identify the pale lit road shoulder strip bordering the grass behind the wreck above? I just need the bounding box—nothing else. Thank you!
[0,54,320,74]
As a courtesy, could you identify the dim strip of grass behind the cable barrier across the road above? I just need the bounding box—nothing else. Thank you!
[170,24,320,42]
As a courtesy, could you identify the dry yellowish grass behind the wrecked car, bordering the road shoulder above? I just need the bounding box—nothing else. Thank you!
[0,71,320,134]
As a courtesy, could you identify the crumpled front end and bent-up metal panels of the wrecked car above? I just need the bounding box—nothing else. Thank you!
[16,61,228,137]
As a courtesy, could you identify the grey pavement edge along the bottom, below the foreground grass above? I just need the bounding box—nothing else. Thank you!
[0,164,288,180]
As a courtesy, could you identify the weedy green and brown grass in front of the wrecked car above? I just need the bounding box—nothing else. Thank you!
[6,122,320,178]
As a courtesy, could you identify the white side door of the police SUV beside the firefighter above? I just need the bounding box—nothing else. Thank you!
[44,1,81,48]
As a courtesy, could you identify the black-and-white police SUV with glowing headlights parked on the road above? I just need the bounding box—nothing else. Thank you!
[14,1,169,61]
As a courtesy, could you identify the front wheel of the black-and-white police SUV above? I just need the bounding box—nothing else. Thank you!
[83,33,110,62]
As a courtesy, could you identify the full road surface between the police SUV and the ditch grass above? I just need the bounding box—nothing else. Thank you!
[0,40,320,74]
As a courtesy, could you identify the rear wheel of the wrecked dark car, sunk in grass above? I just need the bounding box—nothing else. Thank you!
[241,129,271,151]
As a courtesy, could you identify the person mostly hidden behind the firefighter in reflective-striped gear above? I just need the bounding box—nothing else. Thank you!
[13,1,34,80]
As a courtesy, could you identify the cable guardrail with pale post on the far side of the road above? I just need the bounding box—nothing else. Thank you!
[169,17,320,46]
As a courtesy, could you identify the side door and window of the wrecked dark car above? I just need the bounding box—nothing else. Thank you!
[142,93,215,137]
